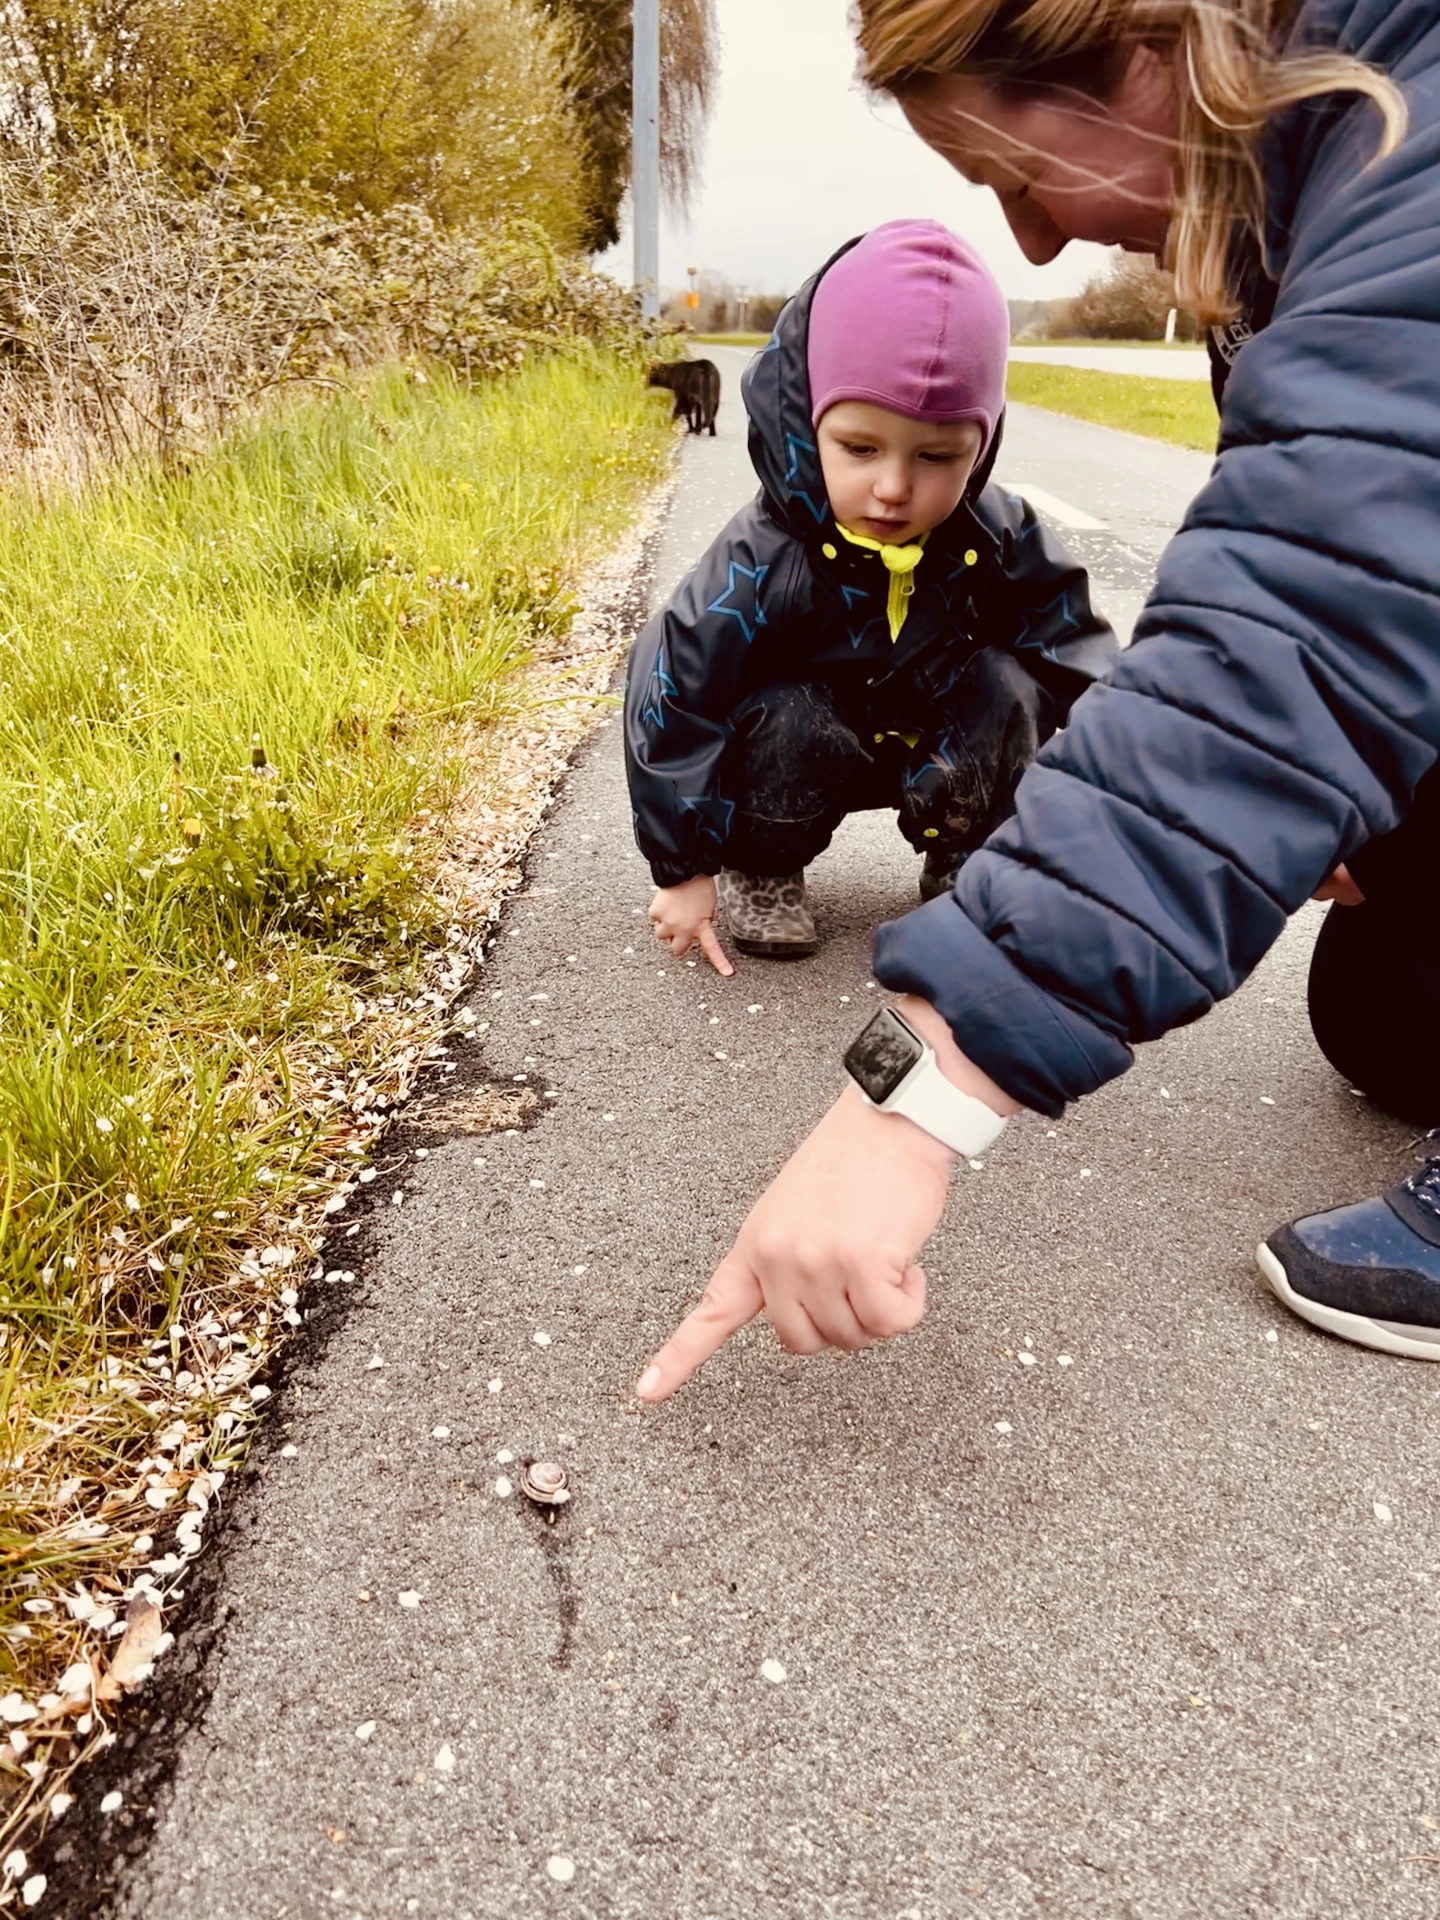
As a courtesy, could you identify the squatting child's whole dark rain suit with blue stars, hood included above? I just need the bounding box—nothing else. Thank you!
[626,242,1116,887]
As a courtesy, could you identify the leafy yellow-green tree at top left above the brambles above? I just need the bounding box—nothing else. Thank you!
[0,0,588,244]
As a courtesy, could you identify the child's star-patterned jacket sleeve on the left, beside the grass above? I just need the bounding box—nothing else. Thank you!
[624,499,797,887]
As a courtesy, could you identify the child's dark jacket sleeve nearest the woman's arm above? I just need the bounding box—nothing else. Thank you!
[975,486,1117,722]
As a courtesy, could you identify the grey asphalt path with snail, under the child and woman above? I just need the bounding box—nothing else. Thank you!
[87,353,1440,1920]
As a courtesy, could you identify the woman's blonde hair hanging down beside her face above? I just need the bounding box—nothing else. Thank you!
[854,0,1407,324]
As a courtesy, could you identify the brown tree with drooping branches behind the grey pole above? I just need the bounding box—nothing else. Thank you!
[541,0,718,252]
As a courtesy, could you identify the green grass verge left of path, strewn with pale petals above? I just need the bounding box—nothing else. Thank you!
[0,349,670,1809]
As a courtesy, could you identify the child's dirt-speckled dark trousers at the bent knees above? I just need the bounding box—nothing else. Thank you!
[722,647,1050,876]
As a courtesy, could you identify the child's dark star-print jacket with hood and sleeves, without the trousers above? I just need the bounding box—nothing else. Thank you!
[626,242,1116,887]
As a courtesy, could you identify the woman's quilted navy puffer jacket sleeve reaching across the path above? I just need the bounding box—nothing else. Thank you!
[876,105,1440,1116]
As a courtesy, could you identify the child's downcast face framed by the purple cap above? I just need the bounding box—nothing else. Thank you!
[818,399,983,547]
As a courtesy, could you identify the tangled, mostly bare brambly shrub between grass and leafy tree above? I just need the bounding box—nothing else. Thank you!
[0,134,647,482]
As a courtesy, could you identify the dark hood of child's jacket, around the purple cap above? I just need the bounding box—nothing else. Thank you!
[739,234,1004,540]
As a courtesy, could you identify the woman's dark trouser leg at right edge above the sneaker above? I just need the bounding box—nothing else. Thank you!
[1309,768,1440,1127]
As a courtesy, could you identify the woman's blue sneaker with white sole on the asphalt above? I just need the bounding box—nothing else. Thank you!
[1256,1129,1440,1359]
